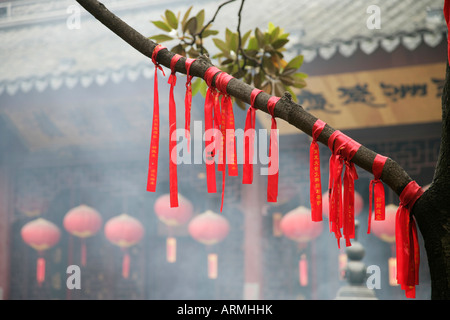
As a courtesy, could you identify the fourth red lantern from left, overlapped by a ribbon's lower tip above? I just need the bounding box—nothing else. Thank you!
[154,194,194,262]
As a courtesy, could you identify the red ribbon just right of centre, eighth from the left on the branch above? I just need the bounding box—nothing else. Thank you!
[267,96,280,202]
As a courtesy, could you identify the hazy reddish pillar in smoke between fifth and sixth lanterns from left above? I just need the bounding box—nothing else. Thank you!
[242,172,263,300]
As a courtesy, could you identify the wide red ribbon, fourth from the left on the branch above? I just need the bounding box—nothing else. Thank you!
[204,67,222,193]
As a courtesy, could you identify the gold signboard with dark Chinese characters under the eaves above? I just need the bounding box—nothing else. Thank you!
[257,63,445,134]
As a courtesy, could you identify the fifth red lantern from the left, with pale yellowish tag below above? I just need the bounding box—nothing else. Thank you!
[188,210,230,279]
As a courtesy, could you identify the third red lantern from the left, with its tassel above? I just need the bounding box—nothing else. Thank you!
[104,213,144,278]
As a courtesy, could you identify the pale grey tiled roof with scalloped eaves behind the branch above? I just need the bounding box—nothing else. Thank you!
[0,0,446,95]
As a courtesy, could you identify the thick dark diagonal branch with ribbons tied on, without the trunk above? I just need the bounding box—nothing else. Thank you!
[76,0,412,195]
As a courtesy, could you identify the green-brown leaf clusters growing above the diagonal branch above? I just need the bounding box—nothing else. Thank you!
[150,6,307,108]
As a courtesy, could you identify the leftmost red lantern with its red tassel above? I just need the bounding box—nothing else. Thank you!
[21,218,61,286]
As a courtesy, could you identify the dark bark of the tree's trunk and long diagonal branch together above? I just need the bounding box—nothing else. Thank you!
[76,0,450,299]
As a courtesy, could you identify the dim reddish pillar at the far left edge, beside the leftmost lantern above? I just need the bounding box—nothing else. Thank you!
[0,166,12,300]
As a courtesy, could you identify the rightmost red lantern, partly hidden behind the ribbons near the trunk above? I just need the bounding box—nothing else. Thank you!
[371,204,398,286]
